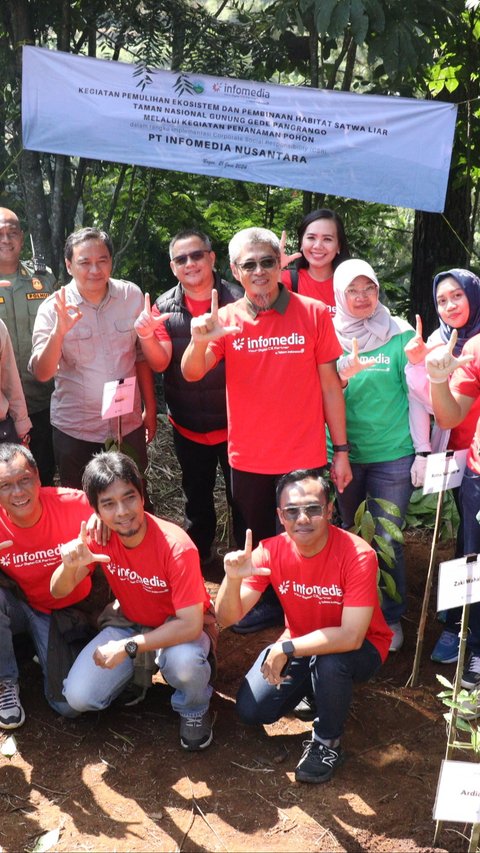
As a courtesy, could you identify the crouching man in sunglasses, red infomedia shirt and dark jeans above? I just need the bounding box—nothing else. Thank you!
[216,469,392,782]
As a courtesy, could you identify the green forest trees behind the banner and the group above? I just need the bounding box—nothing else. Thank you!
[0,0,480,332]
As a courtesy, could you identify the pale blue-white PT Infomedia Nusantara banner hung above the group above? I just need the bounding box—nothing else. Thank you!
[22,47,457,211]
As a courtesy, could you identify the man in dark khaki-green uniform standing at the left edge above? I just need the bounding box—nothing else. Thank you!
[0,207,56,486]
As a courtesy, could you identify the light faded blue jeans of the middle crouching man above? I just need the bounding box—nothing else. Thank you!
[63,626,212,717]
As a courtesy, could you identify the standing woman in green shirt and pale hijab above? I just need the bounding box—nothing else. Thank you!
[333,259,415,651]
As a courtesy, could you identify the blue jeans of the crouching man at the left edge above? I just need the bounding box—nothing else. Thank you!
[0,588,77,717]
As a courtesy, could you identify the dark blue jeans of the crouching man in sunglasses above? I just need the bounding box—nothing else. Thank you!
[236,640,382,740]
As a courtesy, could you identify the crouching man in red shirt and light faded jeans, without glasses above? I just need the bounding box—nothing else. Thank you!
[51,453,214,751]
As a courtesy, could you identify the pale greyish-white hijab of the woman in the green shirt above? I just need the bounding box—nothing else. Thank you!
[333,258,401,352]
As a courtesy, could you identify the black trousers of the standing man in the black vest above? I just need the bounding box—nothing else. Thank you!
[173,427,245,559]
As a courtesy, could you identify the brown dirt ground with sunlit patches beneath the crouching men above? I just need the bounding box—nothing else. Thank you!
[0,426,471,853]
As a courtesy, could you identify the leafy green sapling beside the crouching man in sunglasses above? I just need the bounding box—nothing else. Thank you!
[352,496,403,602]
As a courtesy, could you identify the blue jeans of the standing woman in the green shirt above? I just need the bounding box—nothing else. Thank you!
[337,454,415,624]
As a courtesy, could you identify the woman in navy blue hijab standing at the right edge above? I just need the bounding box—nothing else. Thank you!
[405,268,480,663]
